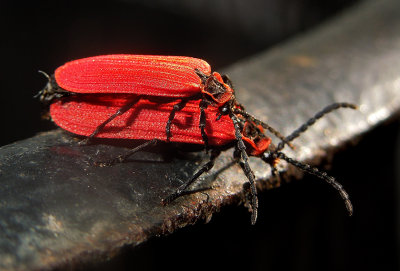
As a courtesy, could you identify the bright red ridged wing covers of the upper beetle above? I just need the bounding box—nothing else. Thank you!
[55,55,211,98]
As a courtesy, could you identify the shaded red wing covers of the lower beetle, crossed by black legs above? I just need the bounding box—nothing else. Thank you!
[50,95,235,145]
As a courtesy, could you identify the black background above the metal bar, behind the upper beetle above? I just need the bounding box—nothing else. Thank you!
[0,0,360,149]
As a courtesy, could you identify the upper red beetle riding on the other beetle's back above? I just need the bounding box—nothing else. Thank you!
[38,55,241,146]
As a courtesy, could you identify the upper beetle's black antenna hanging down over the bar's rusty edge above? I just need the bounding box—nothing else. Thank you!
[229,113,258,225]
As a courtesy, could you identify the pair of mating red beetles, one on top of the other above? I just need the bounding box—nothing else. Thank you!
[38,55,356,224]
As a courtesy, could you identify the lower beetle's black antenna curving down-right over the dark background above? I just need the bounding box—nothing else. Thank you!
[272,152,353,215]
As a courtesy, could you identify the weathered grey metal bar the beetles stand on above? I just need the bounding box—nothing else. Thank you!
[0,0,400,270]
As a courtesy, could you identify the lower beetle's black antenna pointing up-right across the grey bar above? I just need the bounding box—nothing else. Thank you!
[276,103,357,151]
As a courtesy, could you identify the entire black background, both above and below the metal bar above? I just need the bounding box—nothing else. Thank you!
[0,0,400,270]
